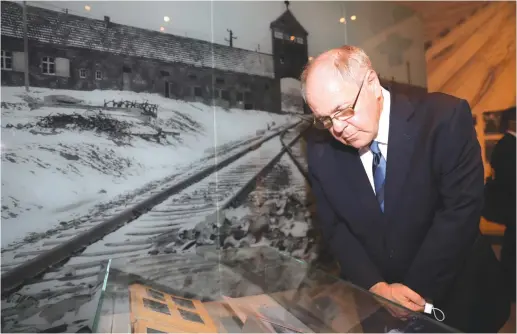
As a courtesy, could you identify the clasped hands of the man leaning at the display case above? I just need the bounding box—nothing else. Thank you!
[370,282,425,317]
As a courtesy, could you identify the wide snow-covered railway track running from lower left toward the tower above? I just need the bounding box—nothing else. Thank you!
[2,119,307,332]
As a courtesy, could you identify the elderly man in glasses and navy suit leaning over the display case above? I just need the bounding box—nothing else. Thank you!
[301,46,509,332]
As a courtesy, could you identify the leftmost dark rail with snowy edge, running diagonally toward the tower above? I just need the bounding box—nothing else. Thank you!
[1,120,298,282]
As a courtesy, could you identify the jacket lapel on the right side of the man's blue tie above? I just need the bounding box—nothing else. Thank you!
[384,93,417,216]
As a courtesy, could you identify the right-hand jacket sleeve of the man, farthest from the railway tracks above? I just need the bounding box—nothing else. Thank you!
[404,100,484,301]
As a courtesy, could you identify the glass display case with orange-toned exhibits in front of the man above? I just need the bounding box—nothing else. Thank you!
[93,246,457,333]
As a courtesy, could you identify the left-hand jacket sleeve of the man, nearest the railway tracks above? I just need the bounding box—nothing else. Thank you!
[309,157,383,289]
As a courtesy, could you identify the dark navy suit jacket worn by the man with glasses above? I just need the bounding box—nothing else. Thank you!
[307,88,508,330]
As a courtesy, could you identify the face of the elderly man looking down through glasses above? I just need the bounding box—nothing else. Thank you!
[306,67,382,149]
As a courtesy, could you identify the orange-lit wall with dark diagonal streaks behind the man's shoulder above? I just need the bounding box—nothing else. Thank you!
[426,2,516,175]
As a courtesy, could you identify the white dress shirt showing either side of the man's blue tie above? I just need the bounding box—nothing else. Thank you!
[359,87,391,193]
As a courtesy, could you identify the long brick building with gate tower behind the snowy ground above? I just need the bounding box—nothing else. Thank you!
[1,1,308,112]
